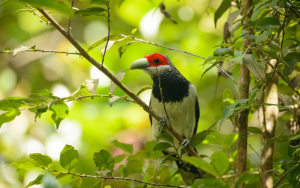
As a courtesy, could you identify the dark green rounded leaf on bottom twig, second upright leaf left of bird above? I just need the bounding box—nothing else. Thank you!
[94,149,115,172]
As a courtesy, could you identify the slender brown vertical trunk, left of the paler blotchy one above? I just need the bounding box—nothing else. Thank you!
[235,0,252,188]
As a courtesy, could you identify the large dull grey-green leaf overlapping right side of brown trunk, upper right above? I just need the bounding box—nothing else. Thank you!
[244,54,266,81]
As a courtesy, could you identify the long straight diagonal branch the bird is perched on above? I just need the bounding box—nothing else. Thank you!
[38,8,201,159]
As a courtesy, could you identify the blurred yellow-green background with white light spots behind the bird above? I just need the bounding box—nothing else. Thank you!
[0,0,287,188]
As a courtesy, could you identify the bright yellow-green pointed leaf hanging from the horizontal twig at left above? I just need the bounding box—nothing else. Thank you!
[49,103,69,129]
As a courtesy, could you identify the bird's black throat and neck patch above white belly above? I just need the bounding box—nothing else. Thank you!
[152,70,190,103]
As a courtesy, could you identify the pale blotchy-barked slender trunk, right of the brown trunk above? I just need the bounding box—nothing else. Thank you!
[260,59,279,188]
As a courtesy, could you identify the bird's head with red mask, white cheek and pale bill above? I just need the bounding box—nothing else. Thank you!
[130,53,172,75]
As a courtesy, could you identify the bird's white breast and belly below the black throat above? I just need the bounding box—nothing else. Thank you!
[151,84,197,153]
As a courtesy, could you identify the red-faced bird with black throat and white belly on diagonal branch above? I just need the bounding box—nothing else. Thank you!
[130,53,205,182]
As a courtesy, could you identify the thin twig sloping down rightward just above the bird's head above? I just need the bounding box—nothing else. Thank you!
[119,34,238,85]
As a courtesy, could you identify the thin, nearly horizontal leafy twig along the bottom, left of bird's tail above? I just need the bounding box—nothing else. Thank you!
[41,167,186,188]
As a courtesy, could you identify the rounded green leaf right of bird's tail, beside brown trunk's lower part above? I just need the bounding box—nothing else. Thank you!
[210,151,229,175]
